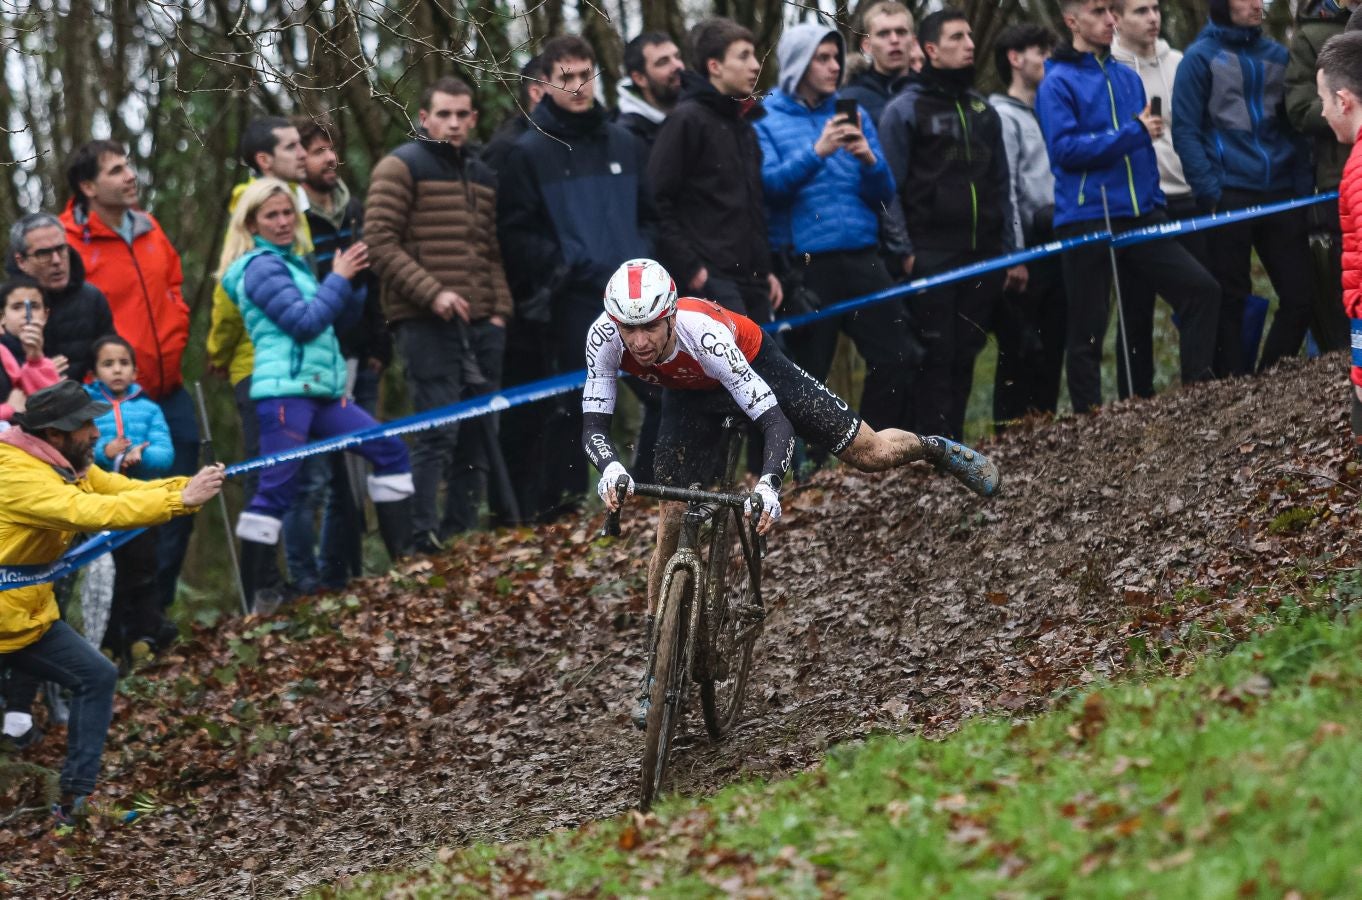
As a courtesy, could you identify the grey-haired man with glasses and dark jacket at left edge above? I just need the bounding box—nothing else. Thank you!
[5,212,113,381]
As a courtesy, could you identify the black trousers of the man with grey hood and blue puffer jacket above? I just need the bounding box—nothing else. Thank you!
[787,246,917,430]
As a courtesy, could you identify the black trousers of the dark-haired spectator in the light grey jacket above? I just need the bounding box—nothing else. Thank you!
[993,247,1066,432]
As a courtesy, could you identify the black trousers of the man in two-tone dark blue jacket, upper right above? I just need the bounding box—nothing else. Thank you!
[1207,188,1314,377]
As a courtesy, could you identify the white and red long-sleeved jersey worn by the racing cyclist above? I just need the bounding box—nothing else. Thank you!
[582,297,776,419]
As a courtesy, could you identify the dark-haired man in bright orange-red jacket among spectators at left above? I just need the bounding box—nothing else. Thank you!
[61,140,199,609]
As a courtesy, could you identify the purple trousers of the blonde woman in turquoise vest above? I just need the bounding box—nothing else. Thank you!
[247,396,411,519]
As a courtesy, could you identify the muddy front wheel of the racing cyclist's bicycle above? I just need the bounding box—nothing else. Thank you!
[639,569,693,811]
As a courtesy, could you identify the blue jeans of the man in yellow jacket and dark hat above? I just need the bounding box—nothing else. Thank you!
[3,621,118,794]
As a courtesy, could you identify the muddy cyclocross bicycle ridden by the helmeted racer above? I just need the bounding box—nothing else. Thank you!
[601,417,765,810]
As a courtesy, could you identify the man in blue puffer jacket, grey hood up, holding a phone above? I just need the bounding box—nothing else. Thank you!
[756,23,917,429]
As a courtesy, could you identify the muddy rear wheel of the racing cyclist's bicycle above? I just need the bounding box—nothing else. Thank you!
[700,512,764,741]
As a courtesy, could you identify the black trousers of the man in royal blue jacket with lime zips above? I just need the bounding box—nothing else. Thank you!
[1056,210,1220,413]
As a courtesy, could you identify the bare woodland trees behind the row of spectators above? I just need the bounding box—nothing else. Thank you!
[0,0,1293,605]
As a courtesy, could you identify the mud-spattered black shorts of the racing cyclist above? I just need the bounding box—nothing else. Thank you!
[652,336,861,487]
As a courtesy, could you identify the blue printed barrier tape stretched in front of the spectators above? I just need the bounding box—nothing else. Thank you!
[0,192,1339,590]
